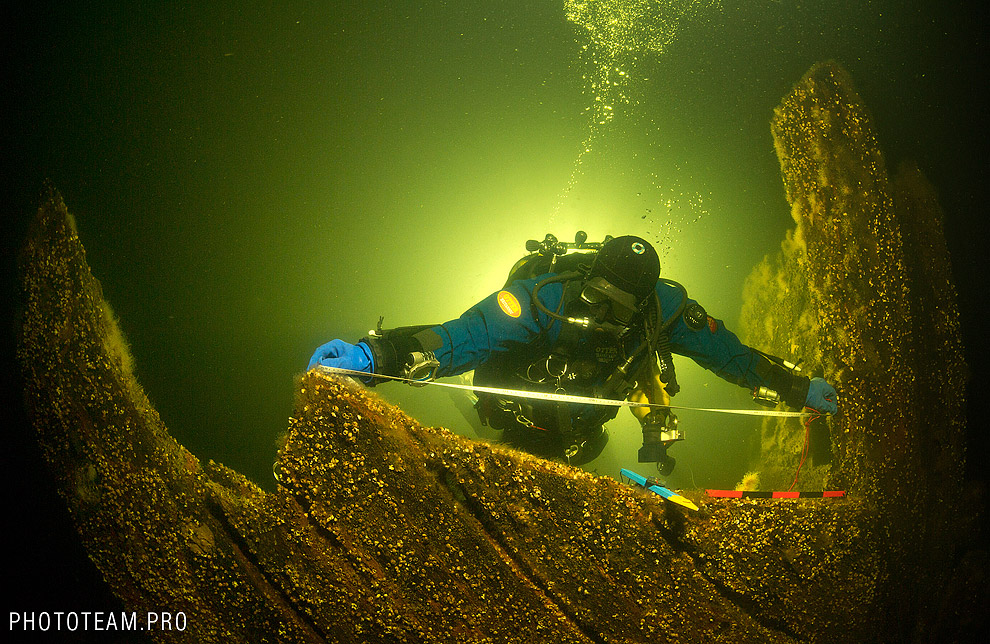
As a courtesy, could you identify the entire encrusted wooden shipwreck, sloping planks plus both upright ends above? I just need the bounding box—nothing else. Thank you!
[19,65,974,643]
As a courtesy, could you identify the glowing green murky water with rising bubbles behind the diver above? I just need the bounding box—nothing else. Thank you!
[7,0,980,487]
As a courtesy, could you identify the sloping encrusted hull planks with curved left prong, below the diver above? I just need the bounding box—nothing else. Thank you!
[20,182,877,642]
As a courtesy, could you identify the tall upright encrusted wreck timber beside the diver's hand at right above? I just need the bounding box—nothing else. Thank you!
[741,63,973,639]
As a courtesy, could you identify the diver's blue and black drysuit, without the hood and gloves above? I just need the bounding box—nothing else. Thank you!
[344,273,809,464]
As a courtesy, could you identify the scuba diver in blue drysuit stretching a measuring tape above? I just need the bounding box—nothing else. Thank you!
[309,231,838,475]
